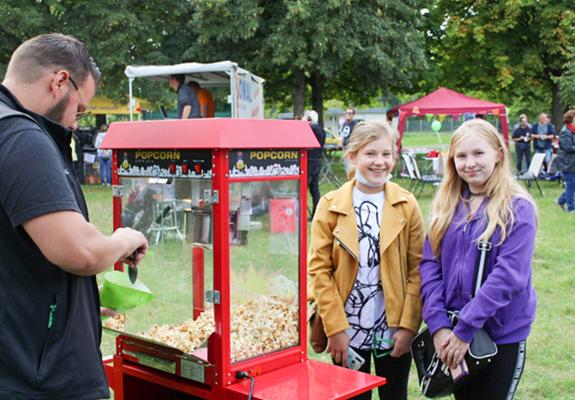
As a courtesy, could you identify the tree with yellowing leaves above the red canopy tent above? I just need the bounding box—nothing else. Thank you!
[427,0,575,125]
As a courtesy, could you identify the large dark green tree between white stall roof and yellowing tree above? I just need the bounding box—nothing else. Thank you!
[185,0,425,123]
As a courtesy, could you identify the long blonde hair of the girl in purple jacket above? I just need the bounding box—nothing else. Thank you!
[428,119,535,257]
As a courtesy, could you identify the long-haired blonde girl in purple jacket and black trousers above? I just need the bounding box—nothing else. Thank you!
[419,119,537,400]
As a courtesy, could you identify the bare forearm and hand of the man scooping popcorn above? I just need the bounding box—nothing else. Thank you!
[23,211,148,276]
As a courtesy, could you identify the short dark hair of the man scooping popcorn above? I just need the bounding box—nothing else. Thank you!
[6,33,101,84]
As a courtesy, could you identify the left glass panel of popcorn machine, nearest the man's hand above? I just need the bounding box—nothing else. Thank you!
[108,177,214,356]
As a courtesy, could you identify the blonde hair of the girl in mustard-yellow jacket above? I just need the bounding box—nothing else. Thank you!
[343,120,397,179]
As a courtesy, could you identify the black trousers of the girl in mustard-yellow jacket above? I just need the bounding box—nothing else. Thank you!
[352,349,411,400]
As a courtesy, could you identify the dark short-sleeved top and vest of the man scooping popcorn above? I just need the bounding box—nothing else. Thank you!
[0,85,109,400]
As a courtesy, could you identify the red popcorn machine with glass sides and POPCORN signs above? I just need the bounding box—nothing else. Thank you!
[103,119,385,400]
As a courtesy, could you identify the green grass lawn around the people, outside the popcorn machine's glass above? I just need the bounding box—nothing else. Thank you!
[84,134,575,400]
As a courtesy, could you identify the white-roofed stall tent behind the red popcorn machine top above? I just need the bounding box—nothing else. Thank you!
[124,61,264,120]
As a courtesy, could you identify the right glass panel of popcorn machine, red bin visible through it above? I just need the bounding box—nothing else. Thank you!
[229,180,299,362]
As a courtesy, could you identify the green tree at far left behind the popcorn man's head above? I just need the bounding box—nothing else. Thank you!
[0,0,191,101]
